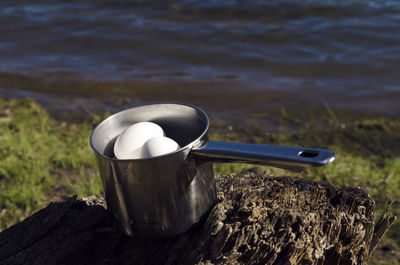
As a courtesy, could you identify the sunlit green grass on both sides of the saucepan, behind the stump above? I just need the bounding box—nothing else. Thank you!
[0,99,400,265]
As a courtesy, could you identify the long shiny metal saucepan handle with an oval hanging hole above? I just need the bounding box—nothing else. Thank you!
[191,141,335,171]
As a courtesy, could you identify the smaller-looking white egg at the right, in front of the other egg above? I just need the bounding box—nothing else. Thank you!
[140,136,180,158]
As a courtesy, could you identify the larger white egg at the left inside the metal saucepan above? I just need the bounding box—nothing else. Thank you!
[114,122,164,159]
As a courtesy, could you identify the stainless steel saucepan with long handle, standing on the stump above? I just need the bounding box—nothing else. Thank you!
[90,103,335,238]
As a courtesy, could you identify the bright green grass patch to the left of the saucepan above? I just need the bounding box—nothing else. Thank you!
[0,99,101,230]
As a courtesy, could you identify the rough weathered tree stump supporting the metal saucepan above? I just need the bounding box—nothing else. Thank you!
[0,173,395,265]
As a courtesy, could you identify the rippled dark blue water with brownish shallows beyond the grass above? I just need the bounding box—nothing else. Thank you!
[0,0,400,119]
